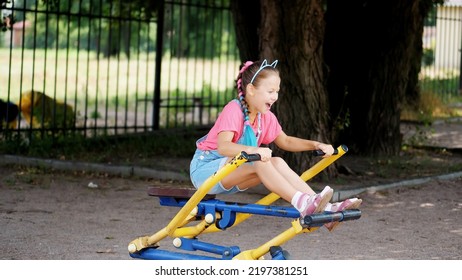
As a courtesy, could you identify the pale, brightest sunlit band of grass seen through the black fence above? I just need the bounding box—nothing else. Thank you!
[0,48,239,102]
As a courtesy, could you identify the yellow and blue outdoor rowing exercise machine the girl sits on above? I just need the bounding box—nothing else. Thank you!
[128,145,361,260]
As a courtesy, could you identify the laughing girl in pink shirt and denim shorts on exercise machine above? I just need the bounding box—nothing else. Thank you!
[190,60,361,230]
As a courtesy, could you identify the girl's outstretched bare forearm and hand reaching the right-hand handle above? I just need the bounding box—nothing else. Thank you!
[274,131,334,156]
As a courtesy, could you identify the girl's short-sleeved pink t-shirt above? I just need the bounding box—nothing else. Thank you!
[197,100,282,151]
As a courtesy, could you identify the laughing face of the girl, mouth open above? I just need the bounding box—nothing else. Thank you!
[245,72,281,114]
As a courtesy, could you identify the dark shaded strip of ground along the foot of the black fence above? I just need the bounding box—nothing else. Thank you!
[0,130,203,165]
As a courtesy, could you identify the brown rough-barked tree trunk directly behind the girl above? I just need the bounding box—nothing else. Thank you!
[259,0,334,175]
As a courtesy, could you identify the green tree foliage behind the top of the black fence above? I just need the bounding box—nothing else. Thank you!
[1,0,236,58]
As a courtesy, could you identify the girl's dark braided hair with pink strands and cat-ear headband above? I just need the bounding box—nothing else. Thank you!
[236,59,279,121]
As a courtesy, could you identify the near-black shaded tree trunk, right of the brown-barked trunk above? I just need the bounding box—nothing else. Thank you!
[325,0,434,155]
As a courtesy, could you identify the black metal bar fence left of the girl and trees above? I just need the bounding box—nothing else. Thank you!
[0,0,239,141]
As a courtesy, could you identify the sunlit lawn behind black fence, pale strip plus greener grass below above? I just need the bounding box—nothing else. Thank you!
[0,48,239,130]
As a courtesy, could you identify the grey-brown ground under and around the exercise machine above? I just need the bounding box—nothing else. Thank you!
[0,121,462,260]
